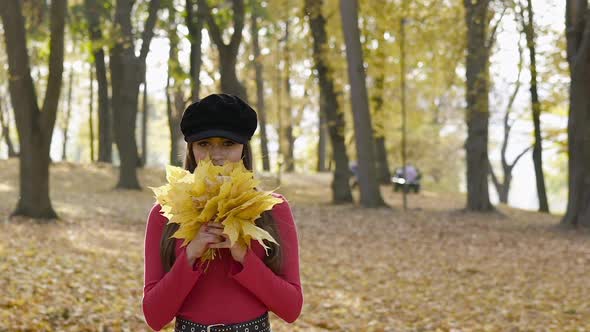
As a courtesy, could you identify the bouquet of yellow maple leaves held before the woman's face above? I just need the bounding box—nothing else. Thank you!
[150,158,283,262]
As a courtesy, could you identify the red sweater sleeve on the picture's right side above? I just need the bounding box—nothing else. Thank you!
[230,196,303,323]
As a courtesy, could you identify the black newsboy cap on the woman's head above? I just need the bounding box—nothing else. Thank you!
[180,93,258,144]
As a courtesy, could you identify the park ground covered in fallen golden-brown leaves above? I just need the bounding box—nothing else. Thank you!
[0,159,590,332]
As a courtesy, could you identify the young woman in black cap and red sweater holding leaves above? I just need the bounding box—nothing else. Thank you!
[143,94,303,332]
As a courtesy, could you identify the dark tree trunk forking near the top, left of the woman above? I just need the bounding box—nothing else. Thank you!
[110,0,160,190]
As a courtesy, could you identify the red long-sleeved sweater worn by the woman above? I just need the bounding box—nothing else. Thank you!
[143,195,303,330]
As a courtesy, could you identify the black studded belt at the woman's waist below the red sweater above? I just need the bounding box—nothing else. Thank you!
[174,312,271,332]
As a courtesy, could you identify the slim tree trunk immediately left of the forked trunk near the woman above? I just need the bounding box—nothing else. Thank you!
[84,0,113,163]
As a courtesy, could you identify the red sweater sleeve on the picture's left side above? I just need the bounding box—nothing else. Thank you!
[142,204,203,331]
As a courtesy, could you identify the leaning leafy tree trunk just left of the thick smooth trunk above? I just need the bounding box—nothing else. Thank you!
[305,0,352,204]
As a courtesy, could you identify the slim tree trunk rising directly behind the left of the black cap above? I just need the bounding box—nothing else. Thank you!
[187,0,205,102]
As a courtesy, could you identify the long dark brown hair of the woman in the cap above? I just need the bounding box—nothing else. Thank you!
[160,142,282,274]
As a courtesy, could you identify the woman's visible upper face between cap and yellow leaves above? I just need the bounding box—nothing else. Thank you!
[192,137,244,166]
